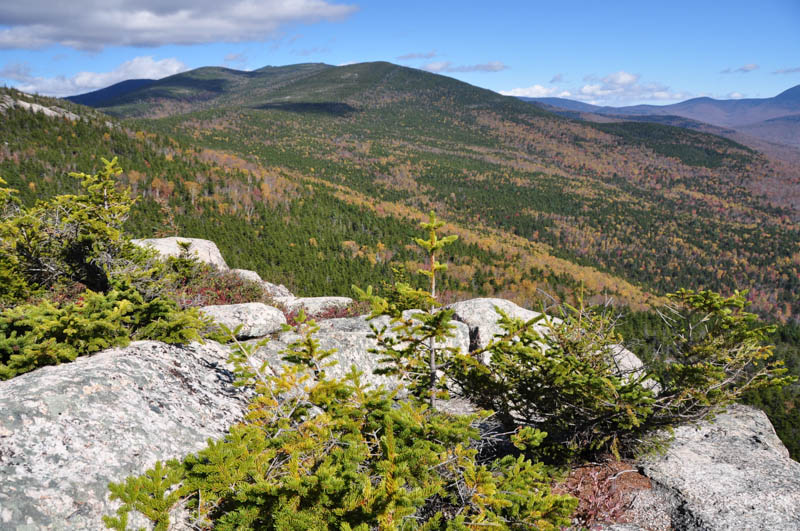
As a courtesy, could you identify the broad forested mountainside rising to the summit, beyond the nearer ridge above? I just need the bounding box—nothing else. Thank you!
[73,63,800,321]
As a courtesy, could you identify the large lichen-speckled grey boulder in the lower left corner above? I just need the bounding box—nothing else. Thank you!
[0,341,248,531]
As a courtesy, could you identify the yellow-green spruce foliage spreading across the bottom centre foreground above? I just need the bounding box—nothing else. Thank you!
[105,318,577,531]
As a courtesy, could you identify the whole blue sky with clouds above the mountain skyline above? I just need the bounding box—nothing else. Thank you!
[0,0,800,105]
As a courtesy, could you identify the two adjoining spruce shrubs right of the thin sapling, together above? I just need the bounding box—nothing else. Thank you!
[453,290,792,461]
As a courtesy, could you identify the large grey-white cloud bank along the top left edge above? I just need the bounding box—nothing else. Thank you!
[0,0,357,51]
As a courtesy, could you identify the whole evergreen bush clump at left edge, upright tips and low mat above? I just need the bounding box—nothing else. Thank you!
[0,158,250,380]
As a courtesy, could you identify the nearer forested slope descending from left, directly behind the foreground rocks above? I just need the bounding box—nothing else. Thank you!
[0,86,651,307]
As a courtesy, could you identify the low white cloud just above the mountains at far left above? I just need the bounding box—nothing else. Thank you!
[0,56,188,96]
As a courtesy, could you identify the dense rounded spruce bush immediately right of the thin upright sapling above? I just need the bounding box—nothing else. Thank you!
[452,307,654,462]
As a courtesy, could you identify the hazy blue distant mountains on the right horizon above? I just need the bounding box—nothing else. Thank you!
[521,85,800,147]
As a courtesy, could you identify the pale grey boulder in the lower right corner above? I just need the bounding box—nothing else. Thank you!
[631,405,800,531]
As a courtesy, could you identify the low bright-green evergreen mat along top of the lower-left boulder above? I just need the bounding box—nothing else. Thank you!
[0,280,210,380]
